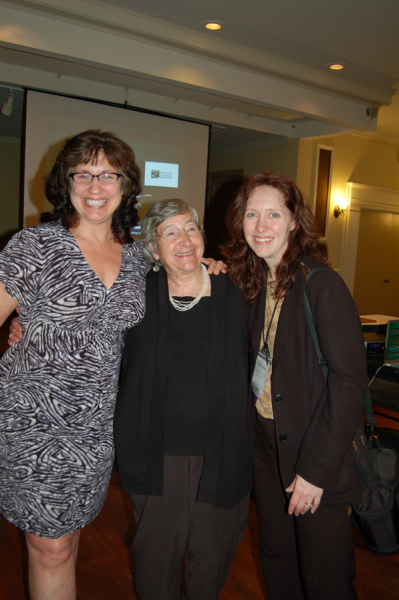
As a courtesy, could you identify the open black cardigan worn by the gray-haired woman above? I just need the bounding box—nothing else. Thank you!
[115,269,252,508]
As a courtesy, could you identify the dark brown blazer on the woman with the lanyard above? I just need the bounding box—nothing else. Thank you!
[249,257,367,505]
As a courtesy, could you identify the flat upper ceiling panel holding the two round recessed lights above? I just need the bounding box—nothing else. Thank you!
[108,0,399,88]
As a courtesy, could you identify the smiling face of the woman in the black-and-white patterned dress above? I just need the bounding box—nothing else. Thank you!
[70,152,122,226]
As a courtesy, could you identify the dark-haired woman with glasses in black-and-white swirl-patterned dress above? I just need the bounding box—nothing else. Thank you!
[0,130,147,600]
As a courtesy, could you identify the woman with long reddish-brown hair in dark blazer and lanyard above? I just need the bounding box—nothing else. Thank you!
[224,173,367,600]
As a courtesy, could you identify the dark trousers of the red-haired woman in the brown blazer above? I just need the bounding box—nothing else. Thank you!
[254,415,357,600]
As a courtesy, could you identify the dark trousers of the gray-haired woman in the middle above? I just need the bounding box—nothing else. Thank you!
[132,456,249,600]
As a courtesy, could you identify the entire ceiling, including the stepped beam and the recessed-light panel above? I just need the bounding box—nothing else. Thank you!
[0,0,399,154]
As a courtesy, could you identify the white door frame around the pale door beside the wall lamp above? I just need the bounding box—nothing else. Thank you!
[341,181,399,295]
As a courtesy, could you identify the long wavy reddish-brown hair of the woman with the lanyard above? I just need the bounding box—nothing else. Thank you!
[222,173,331,304]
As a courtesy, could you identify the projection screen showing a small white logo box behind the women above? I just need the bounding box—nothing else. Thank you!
[23,90,209,227]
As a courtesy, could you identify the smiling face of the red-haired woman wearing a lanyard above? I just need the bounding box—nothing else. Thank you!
[243,186,295,277]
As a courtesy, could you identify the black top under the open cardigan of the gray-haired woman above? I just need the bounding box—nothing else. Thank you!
[163,296,211,456]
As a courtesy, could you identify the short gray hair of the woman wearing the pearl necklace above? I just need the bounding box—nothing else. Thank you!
[140,199,201,264]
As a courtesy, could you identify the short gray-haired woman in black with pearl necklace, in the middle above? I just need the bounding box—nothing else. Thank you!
[115,200,252,600]
